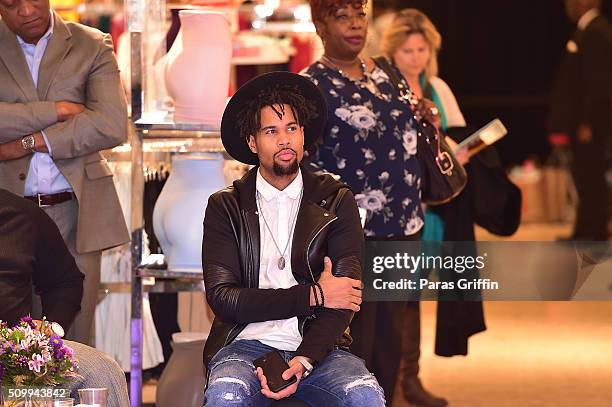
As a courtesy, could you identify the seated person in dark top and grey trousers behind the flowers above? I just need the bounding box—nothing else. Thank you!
[0,188,130,407]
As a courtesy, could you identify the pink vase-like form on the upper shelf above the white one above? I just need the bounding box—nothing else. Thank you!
[166,10,232,123]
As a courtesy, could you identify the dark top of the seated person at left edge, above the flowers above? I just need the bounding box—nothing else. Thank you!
[0,189,83,328]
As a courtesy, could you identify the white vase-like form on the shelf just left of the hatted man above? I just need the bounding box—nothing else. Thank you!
[153,153,225,272]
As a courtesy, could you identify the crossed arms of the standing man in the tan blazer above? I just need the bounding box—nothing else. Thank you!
[0,35,127,161]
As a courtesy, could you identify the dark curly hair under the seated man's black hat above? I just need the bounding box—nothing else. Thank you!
[236,85,318,139]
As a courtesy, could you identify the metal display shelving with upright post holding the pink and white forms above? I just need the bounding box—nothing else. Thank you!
[125,0,224,407]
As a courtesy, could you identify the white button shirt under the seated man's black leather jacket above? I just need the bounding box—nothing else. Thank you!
[236,171,303,351]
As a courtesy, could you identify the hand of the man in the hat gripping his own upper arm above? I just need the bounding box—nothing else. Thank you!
[310,256,361,312]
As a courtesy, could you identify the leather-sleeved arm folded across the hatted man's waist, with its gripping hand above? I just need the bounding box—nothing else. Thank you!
[202,195,361,332]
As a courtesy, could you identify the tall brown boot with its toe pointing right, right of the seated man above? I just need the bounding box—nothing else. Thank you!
[402,302,448,407]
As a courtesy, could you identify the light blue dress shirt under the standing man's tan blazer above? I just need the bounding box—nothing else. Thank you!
[17,14,72,196]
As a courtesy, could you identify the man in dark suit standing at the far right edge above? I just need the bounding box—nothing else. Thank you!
[551,0,612,240]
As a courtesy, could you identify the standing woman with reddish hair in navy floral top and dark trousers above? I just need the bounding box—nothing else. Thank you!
[303,0,436,406]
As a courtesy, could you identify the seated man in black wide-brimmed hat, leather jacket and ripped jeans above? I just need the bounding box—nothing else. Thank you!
[202,72,385,407]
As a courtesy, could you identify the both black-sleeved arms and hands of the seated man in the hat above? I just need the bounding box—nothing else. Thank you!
[202,190,363,399]
